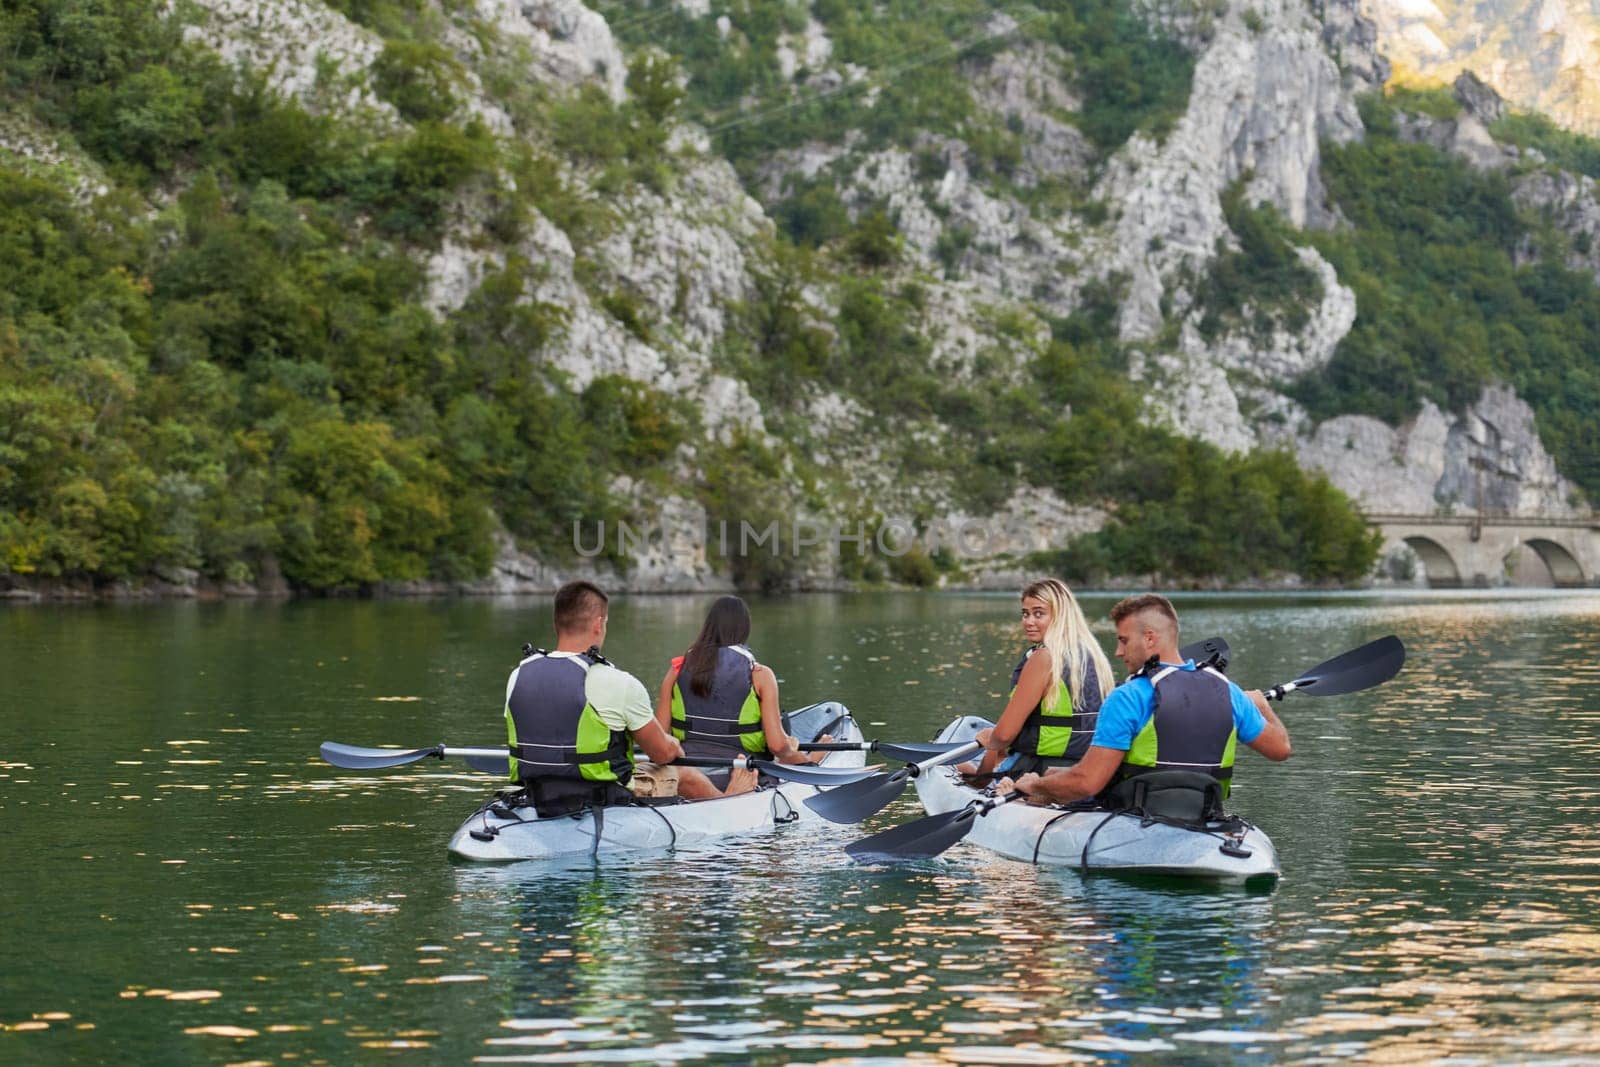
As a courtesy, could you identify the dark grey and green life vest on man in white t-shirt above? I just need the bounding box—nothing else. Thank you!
[506,648,634,798]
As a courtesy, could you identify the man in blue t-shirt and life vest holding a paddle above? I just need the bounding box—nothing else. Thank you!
[1000,593,1291,803]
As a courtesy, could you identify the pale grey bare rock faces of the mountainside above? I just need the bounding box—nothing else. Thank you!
[172,0,1600,589]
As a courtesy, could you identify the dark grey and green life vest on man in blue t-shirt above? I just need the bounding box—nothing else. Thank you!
[1118,664,1238,797]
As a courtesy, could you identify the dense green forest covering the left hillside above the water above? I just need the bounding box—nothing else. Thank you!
[0,0,685,590]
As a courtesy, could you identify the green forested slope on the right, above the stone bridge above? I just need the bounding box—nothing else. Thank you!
[1298,93,1600,499]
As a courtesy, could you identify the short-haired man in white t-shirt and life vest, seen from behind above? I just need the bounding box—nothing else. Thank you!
[506,581,755,809]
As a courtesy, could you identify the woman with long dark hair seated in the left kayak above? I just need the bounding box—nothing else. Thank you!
[656,597,829,763]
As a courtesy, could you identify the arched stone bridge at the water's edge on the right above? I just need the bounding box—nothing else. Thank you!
[1366,514,1600,589]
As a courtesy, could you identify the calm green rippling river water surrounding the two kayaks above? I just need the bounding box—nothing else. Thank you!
[0,592,1600,1064]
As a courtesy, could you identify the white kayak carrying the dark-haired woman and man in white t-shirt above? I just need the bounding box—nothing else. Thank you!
[450,701,867,864]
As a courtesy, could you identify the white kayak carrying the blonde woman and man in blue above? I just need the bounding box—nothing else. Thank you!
[915,715,1280,885]
